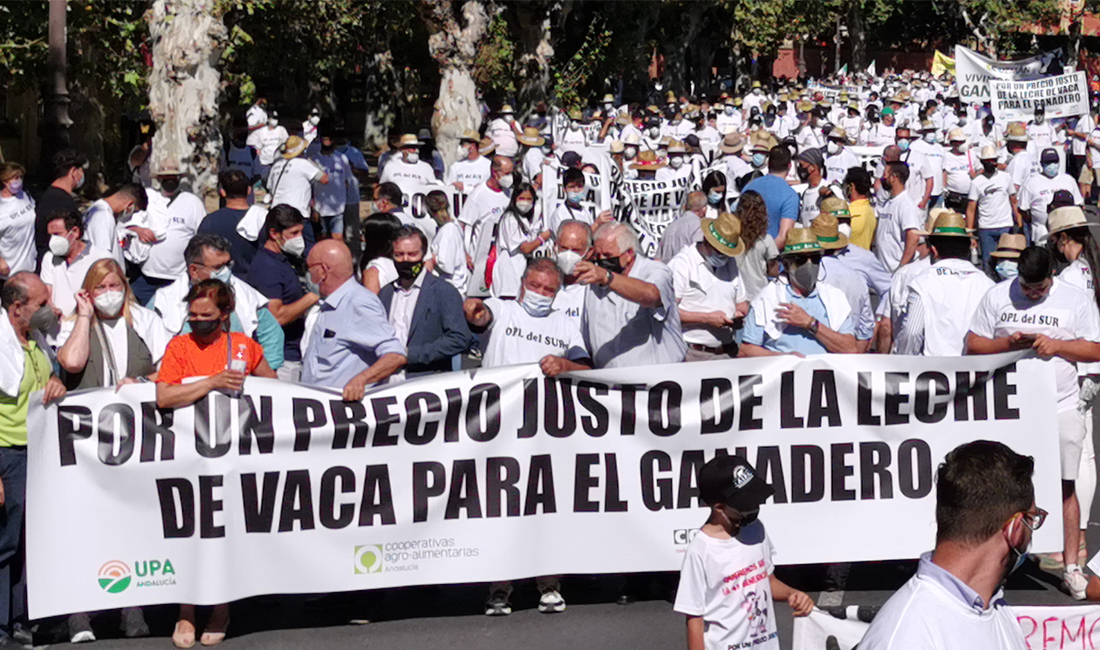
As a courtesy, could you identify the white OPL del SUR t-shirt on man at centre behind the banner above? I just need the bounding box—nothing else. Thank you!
[481,298,589,367]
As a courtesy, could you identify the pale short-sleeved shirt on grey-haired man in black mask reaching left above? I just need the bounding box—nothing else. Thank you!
[581,254,688,367]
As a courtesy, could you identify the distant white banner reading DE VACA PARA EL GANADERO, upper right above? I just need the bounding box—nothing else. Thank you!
[989,73,1089,121]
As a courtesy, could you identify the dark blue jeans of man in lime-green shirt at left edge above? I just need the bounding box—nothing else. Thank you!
[0,447,26,638]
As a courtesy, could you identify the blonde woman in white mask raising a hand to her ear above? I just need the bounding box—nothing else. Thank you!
[57,258,172,390]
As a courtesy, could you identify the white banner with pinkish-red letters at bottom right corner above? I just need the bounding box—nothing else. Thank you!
[791,605,1100,650]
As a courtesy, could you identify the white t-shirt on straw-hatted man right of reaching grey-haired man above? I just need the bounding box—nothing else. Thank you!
[669,245,749,348]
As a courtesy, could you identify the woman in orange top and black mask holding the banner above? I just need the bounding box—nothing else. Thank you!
[156,279,275,648]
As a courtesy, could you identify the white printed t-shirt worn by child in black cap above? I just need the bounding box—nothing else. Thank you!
[672,520,780,650]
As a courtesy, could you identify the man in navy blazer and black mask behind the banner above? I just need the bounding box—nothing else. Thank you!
[378,225,473,377]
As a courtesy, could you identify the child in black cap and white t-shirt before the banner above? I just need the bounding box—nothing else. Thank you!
[673,455,814,650]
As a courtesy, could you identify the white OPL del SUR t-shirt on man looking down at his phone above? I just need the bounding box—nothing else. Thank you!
[970,277,1100,412]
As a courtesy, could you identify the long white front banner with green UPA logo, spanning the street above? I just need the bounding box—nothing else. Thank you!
[26,354,1062,618]
